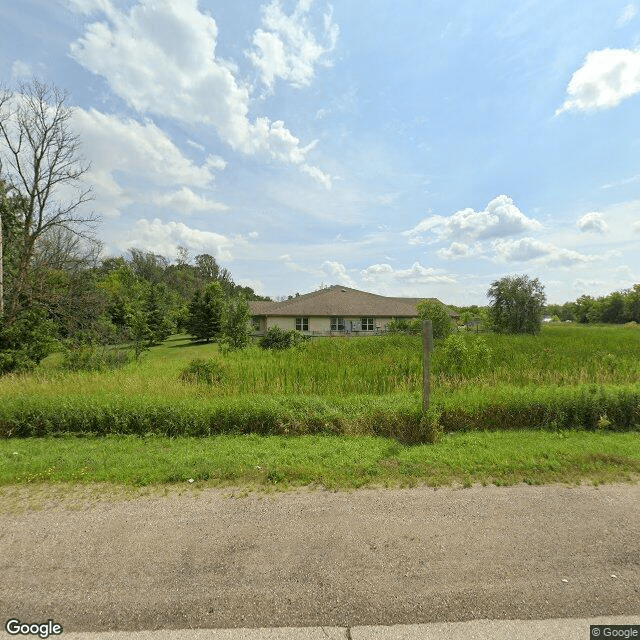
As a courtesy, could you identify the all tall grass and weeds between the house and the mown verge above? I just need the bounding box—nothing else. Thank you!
[0,326,640,442]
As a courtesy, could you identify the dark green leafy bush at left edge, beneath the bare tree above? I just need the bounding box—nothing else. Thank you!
[0,308,57,375]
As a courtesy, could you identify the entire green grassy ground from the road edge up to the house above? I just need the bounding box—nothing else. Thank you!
[0,325,640,488]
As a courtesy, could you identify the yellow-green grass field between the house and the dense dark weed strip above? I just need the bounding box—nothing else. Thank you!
[0,326,640,399]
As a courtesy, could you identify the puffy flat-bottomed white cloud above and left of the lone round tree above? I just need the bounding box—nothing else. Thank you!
[404,195,542,244]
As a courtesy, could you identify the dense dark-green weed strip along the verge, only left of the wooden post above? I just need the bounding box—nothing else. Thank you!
[0,395,420,438]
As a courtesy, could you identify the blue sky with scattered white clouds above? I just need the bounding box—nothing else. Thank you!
[0,0,640,305]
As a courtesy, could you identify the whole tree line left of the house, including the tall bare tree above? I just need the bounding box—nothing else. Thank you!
[0,80,268,373]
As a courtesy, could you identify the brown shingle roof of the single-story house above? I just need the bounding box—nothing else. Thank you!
[249,285,457,318]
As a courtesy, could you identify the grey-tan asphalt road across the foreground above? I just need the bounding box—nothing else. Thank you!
[0,485,640,640]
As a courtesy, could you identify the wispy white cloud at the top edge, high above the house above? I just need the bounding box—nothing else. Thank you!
[247,0,339,89]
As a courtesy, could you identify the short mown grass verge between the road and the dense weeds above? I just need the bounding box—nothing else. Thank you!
[0,431,640,489]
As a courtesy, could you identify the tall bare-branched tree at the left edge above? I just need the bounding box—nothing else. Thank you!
[0,80,97,324]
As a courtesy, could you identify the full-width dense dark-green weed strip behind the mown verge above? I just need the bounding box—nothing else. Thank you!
[0,385,640,442]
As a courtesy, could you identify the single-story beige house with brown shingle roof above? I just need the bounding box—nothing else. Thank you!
[249,285,459,336]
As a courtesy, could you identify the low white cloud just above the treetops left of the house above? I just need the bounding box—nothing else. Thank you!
[119,218,234,260]
